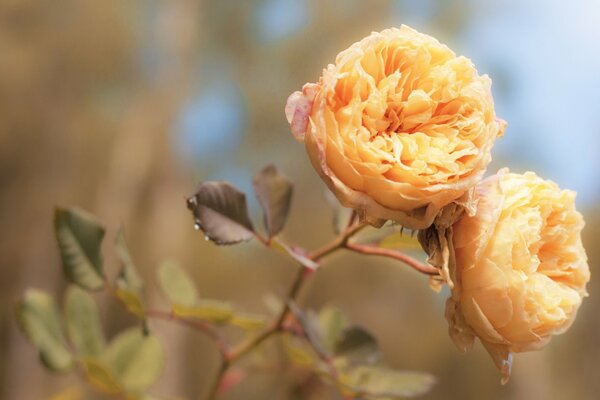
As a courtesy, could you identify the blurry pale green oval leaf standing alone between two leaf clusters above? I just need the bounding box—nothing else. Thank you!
[158,261,198,307]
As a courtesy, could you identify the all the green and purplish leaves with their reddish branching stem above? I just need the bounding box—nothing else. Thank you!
[17,170,434,400]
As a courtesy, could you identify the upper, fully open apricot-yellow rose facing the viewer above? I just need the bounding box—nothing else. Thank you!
[285,26,506,229]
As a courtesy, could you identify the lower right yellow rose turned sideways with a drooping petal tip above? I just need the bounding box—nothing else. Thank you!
[446,169,590,382]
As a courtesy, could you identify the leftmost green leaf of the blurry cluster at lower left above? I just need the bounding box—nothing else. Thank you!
[16,289,73,372]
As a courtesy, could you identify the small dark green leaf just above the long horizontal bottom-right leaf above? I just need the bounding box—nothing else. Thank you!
[333,326,380,363]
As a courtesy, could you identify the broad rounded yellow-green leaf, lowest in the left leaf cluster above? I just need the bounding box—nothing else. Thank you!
[101,328,164,392]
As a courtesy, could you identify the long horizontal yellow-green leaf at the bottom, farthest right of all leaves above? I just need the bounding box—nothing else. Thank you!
[340,365,435,399]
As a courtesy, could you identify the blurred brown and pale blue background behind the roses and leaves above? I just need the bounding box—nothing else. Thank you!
[0,0,600,400]
